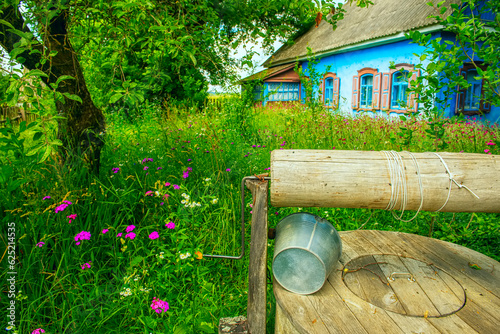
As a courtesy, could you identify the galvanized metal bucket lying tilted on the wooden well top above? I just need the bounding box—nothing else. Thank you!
[273,212,342,295]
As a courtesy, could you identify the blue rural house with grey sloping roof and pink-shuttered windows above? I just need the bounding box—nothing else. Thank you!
[241,0,500,122]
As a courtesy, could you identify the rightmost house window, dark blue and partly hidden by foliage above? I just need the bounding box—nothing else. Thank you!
[456,63,491,115]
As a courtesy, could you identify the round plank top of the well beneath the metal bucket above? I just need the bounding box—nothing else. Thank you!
[274,231,500,334]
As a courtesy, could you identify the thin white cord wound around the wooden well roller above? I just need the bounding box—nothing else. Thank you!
[382,151,479,219]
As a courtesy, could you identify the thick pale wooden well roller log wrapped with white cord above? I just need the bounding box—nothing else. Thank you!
[271,150,500,212]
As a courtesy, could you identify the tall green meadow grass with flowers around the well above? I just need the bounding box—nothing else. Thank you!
[0,100,500,333]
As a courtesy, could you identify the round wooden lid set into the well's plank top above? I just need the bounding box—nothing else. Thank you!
[342,254,466,318]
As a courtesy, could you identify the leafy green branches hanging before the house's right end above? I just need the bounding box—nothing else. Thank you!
[407,0,500,118]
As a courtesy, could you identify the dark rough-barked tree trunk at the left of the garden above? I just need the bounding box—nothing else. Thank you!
[0,5,105,172]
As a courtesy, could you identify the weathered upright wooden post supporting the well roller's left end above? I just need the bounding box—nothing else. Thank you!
[246,180,268,334]
